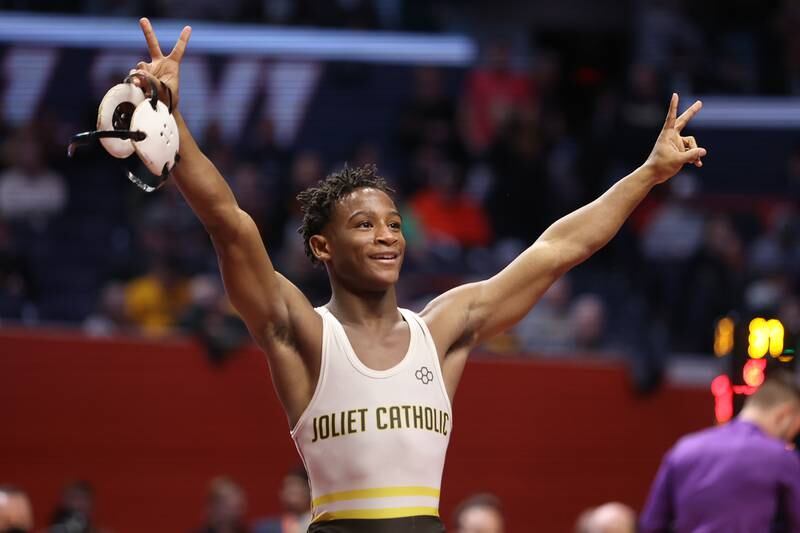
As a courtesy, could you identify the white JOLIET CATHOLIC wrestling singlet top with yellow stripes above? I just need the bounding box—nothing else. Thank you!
[291,308,453,522]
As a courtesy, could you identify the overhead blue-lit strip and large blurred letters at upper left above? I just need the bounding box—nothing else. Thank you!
[0,12,476,146]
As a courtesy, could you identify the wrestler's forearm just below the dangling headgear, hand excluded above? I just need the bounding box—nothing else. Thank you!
[173,111,239,236]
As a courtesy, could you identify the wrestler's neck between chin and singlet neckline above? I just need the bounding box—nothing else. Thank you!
[326,283,402,328]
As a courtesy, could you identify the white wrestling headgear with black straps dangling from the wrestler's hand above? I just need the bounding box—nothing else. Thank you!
[67,74,180,192]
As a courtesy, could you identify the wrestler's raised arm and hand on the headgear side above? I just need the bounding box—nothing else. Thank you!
[137,18,322,424]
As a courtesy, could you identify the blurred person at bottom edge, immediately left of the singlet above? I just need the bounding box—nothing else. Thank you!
[252,466,311,533]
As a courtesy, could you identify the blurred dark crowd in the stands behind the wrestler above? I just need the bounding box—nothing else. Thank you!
[0,0,800,385]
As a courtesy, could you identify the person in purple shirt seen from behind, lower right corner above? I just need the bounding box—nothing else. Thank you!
[639,371,800,533]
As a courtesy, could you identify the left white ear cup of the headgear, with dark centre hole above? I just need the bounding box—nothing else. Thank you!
[97,83,147,156]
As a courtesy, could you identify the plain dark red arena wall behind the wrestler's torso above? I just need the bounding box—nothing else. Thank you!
[0,329,713,533]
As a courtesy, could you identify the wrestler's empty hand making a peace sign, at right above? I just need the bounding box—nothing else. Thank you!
[645,93,706,183]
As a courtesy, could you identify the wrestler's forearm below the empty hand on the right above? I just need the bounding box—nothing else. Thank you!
[539,166,656,270]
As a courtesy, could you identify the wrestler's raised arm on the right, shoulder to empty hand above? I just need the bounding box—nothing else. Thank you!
[422,95,706,358]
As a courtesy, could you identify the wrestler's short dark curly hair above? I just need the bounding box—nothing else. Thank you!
[297,164,394,265]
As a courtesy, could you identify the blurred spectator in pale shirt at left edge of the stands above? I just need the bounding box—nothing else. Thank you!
[0,128,67,229]
